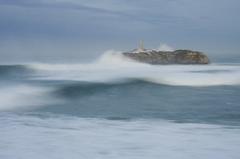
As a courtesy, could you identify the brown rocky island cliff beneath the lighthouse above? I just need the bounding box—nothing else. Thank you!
[122,50,210,65]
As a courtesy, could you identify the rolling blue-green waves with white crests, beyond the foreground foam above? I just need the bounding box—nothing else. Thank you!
[0,51,240,124]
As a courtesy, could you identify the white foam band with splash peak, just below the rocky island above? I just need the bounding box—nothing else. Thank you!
[29,51,240,86]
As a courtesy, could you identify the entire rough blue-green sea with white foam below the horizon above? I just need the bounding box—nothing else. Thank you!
[0,53,240,159]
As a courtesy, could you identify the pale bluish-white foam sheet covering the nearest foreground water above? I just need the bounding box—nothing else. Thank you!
[0,115,240,159]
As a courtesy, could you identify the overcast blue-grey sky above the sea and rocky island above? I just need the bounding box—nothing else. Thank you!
[0,0,240,62]
